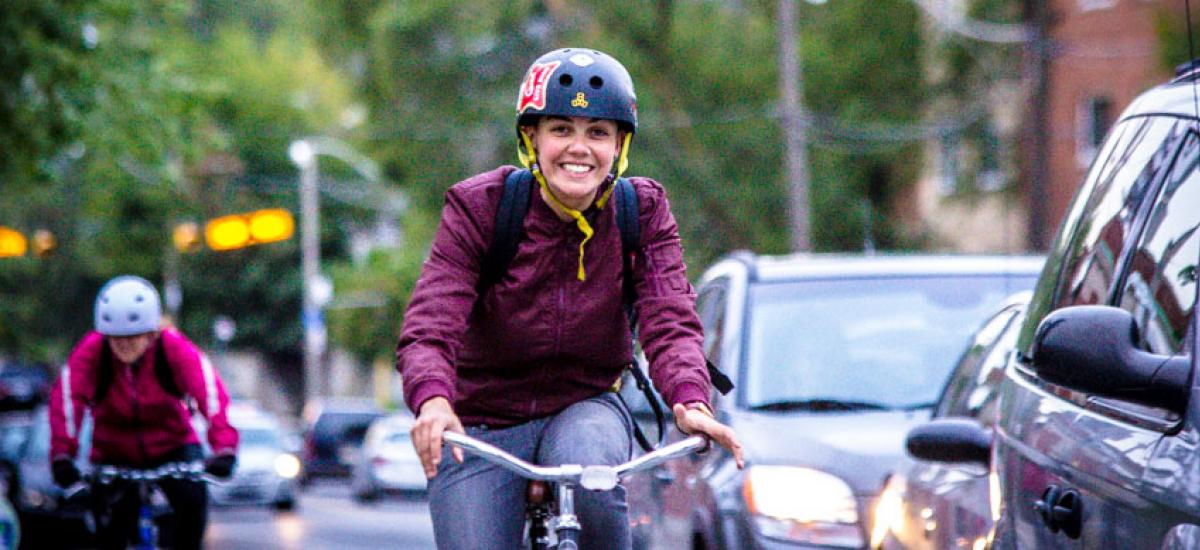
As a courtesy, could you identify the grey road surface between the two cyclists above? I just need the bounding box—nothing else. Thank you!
[205,483,433,550]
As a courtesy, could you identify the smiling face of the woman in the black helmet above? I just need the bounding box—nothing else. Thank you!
[521,116,623,210]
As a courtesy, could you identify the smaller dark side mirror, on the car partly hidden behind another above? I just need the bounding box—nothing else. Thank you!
[905,418,991,466]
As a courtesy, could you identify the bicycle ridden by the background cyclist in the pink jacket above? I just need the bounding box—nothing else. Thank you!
[65,460,217,550]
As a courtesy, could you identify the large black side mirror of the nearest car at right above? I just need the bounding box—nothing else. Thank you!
[1031,305,1192,413]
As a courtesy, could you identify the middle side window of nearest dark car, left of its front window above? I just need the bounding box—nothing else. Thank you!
[1054,116,1187,309]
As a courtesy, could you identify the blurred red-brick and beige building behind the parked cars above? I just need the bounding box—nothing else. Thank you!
[895,0,1183,252]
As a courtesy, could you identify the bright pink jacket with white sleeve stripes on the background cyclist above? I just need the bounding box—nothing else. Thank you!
[49,329,238,466]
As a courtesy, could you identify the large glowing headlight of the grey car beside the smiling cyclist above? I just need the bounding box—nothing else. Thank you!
[743,466,865,548]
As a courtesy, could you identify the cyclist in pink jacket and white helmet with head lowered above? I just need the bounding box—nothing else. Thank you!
[49,276,238,548]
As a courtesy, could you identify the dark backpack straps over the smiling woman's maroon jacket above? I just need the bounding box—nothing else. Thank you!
[476,169,733,450]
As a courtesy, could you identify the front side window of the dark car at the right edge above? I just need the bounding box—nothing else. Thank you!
[1118,134,1200,355]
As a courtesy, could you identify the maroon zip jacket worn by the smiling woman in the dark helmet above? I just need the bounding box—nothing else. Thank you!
[396,166,710,426]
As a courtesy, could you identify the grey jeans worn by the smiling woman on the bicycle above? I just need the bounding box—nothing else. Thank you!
[430,393,634,550]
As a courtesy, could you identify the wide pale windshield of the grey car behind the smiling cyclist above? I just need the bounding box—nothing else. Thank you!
[743,275,1034,411]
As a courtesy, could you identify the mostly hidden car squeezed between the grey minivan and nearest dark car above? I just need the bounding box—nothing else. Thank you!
[871,291,1031,550]
